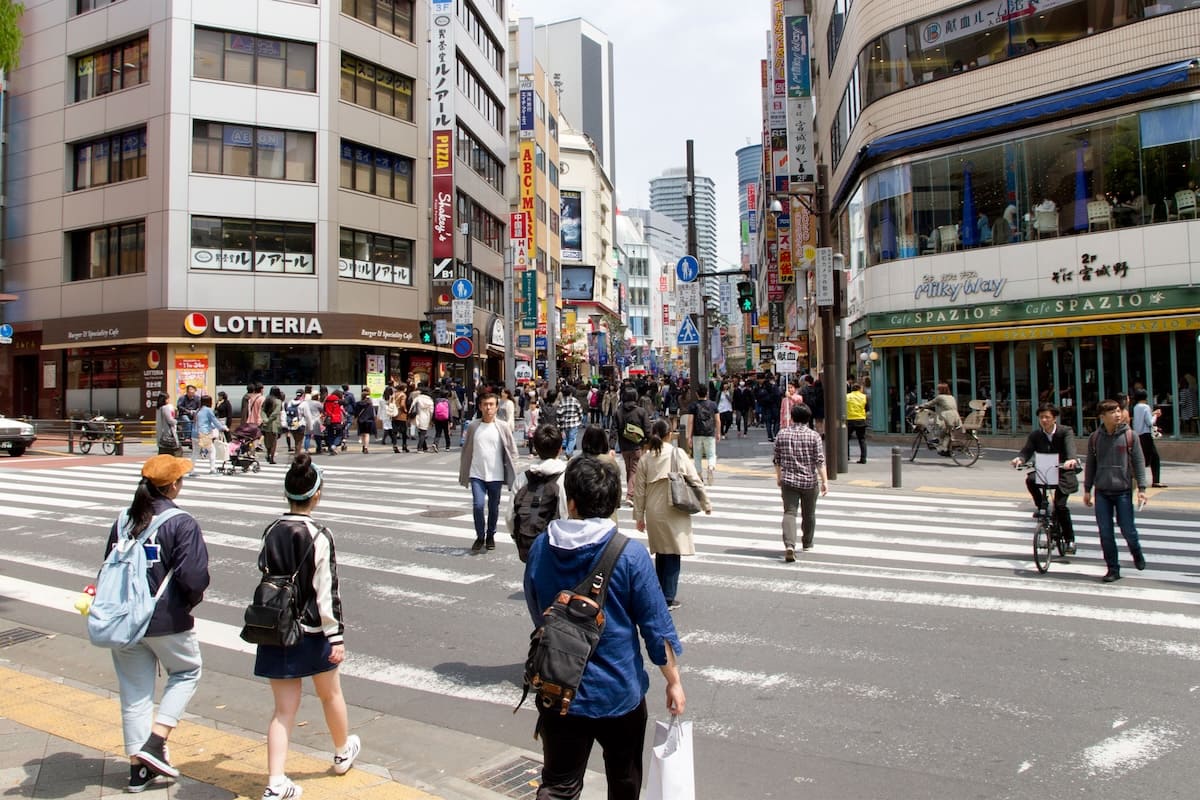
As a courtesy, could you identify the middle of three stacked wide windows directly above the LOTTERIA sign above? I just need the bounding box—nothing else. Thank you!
[192,120,317,182]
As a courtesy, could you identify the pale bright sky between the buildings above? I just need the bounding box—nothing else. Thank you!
[510,0,770,264]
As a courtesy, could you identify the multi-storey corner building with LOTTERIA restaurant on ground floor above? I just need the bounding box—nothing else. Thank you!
[0,0,508,419]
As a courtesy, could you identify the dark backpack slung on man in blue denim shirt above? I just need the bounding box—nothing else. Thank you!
[512,533,629,730]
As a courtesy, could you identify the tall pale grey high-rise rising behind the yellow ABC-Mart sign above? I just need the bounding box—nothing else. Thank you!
[534,18,617,186]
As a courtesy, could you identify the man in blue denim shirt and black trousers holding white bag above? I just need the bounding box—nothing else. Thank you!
[524,457,685,800]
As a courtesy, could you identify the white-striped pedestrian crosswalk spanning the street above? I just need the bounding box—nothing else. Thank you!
[0,456,1200,782]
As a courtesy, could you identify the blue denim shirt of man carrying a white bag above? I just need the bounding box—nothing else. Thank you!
[524,519,683,718]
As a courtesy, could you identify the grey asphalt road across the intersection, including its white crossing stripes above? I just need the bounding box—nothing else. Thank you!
[0,439,1200,800]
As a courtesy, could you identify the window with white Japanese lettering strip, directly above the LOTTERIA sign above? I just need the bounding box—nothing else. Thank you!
[191,217,316,275]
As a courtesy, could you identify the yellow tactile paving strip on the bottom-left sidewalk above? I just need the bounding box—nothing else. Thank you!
[0,667,437,800]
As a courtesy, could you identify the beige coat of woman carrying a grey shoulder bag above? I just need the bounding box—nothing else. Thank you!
[634,441,713,555]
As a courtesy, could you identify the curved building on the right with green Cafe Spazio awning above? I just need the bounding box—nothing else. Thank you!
[810,0,1200,438]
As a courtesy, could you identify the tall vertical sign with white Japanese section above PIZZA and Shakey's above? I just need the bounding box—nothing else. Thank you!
[430,0,457,259]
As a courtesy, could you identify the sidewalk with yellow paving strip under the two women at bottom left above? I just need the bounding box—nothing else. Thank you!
[0,618,606,800]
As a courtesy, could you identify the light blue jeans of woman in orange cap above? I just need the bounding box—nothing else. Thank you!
[113,631,200,756]
